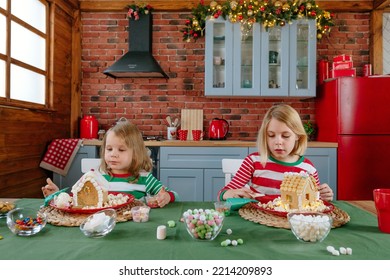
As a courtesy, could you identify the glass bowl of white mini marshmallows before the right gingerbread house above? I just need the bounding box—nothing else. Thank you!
[287,212,333,243]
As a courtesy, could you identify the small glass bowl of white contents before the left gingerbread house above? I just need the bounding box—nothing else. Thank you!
[80,208,117,238]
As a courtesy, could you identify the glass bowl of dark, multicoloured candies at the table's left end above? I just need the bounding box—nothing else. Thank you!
[7,207,46,236]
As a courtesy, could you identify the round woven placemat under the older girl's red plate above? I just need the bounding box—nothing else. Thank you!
[238,203,350,229]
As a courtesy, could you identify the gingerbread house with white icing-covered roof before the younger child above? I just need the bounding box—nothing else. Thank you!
[72,171,108,208]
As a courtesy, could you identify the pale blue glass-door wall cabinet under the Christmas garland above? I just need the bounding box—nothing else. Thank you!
[205,19,316,98]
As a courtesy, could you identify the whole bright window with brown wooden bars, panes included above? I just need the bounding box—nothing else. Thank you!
[0,0,48,108]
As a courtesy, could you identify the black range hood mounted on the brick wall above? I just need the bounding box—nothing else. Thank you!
[103,14,169,79]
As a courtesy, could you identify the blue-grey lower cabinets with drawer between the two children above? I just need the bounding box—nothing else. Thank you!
[160,147,248,201]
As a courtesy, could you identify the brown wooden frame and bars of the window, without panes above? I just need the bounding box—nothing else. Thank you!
[0,0,53,110]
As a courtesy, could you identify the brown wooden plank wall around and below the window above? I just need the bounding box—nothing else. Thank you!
[0,0,77,198]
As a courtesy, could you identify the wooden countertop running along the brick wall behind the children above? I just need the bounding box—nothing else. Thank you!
[83,139,337,148]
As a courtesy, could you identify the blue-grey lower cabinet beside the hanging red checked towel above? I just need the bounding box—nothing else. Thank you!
[53,146,99,189]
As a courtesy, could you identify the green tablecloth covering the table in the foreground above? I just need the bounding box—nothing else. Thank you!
[0,199,390,260]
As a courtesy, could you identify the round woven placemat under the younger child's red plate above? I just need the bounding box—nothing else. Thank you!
[39,200,144,227]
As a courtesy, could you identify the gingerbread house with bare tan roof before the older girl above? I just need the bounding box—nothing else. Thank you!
[280,172,319,210]
